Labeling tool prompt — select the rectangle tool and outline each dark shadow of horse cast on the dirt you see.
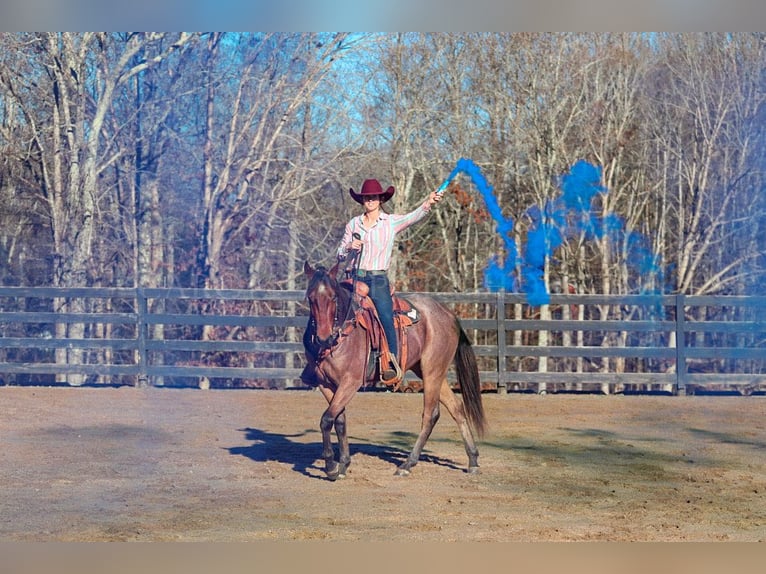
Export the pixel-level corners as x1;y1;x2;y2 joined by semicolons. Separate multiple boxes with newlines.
226;427;461;480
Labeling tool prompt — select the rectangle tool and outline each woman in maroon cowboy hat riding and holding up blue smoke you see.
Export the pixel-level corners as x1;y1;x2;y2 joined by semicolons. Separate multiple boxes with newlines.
338;179;442;381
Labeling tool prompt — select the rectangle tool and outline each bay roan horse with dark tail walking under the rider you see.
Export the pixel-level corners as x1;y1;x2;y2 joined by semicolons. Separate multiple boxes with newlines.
304;262;486;480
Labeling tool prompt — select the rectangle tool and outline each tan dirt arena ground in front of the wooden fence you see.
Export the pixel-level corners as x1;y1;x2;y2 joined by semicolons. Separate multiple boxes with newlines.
0;387;766;542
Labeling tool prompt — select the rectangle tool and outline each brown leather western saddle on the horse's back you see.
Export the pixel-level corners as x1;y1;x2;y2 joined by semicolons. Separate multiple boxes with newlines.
340;279;420;388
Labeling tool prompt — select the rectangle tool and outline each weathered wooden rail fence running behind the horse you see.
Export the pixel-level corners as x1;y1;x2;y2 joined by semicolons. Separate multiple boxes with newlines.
0;287;766;394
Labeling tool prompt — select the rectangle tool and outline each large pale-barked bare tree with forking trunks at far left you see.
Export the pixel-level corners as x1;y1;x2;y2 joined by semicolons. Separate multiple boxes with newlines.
0;33;195;385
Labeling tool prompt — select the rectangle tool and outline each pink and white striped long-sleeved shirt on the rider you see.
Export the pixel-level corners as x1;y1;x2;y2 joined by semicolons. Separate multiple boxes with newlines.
338;200;431;271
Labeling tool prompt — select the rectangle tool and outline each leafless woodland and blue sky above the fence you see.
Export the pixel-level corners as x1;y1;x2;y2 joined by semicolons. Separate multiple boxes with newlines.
0;32;766;300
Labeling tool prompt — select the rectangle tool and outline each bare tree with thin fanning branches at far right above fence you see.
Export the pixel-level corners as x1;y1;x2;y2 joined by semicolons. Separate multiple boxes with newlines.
648;34;766;294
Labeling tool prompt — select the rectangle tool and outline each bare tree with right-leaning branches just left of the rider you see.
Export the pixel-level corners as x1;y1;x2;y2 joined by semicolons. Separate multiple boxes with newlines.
192;34;364;287
